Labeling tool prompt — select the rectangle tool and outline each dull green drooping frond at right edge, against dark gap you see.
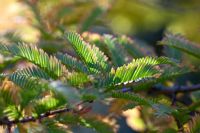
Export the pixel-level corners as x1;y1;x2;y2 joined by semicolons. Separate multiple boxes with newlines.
160;33;200;58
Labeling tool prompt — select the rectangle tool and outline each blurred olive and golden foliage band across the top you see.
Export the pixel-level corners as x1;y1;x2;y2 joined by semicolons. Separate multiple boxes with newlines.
0;0;200;44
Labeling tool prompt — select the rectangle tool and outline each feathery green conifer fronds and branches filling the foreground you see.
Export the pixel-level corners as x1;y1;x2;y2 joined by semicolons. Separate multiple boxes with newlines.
0;32;200;133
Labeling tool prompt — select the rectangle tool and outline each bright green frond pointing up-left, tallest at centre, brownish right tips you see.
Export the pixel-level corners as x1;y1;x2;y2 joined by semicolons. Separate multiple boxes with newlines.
65;32;110;73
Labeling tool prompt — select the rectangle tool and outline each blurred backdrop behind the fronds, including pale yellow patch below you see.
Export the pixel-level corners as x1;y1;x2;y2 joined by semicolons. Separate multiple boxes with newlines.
0;0;200;133
